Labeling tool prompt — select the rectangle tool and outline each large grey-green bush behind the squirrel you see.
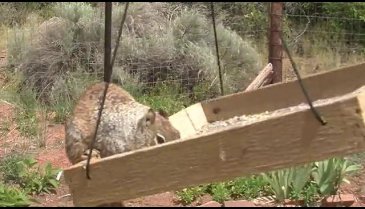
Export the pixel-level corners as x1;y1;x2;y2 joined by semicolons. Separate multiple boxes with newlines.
9;2;261;110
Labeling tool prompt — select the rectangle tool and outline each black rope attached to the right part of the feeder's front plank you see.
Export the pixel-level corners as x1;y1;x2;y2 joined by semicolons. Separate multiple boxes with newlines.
280;35;327;125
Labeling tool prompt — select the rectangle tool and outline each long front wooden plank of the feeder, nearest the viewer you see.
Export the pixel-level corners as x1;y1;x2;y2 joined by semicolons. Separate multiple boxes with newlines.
64;91;365;206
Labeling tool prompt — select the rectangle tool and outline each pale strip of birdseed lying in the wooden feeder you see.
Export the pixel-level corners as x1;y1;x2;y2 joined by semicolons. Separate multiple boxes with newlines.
196;86;365;135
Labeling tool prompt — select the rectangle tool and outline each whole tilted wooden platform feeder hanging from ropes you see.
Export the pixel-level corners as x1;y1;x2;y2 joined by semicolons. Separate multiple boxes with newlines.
64;63;365;206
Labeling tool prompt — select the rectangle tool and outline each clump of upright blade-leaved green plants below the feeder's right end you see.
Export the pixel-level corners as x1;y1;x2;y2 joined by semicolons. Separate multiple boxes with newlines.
262;158;360;204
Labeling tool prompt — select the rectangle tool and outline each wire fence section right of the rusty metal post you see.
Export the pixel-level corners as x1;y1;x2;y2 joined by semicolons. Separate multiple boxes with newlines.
283;2;365;80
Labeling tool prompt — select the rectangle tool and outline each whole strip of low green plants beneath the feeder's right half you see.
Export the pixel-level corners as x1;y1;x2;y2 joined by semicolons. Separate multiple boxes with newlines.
176;158;360;206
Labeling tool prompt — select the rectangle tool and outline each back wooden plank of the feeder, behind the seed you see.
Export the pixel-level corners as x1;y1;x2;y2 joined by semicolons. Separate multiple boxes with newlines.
201;63;365;122
